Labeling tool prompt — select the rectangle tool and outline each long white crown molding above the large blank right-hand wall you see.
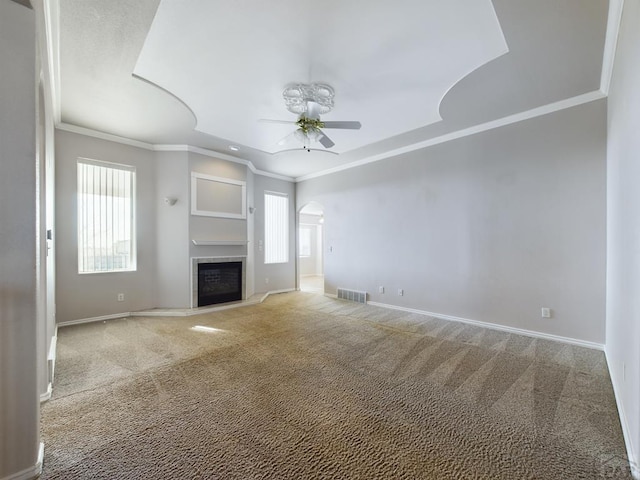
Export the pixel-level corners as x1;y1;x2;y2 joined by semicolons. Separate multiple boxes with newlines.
295;90;606;182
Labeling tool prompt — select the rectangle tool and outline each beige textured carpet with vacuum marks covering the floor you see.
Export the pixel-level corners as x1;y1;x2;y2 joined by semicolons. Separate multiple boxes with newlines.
42;292;630;480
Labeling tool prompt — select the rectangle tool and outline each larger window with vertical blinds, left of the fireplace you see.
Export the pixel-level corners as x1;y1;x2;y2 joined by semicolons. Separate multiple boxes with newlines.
78;159;136;273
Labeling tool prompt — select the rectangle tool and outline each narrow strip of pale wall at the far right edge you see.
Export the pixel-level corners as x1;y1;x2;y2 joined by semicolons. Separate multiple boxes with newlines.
606;0;640;472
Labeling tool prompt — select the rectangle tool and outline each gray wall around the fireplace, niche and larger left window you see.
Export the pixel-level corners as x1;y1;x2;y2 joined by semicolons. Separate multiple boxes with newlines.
56;135;254;312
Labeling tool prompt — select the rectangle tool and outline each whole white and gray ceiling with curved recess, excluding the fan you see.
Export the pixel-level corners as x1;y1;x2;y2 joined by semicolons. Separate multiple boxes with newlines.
60;0;608;177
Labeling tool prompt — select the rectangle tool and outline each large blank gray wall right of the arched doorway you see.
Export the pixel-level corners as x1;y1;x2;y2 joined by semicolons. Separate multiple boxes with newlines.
297;101;606;343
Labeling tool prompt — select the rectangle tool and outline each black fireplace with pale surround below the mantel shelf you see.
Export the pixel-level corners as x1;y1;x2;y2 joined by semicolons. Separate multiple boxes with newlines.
192;257;245;307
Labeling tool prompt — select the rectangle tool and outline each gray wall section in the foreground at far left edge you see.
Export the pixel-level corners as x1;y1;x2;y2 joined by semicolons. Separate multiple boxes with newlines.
0;1;43;478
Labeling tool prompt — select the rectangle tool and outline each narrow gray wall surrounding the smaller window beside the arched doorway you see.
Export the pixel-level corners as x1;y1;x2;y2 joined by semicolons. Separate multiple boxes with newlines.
253;175;296;293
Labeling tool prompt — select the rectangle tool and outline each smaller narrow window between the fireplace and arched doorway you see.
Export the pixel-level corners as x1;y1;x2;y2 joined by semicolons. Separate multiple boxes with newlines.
264;192;289;263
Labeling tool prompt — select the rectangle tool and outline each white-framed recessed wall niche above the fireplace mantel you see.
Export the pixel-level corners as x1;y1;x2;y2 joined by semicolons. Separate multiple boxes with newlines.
191;172;247;220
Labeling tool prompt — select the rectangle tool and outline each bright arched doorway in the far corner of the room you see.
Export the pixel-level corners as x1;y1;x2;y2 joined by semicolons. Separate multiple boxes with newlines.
297;202;324;294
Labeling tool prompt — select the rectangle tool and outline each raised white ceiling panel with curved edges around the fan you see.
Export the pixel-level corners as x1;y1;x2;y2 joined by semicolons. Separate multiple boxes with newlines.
133;0;508;154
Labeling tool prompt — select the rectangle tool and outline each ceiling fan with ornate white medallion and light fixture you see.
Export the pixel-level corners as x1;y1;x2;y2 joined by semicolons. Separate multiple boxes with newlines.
261;83;362;152
